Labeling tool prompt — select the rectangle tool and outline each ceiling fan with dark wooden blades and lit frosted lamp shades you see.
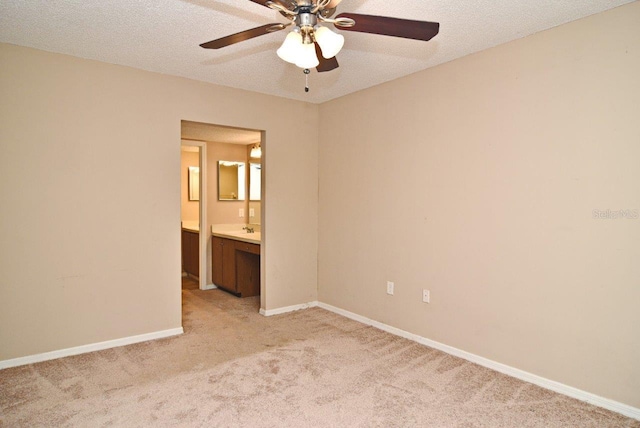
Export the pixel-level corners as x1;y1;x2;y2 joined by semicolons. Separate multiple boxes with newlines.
200;0;440;91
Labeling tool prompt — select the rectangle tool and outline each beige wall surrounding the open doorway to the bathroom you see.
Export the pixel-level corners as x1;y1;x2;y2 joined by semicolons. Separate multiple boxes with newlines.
0;44;318;360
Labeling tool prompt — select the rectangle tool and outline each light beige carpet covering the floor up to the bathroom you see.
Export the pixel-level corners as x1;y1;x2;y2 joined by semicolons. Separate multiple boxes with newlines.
0;280;640;428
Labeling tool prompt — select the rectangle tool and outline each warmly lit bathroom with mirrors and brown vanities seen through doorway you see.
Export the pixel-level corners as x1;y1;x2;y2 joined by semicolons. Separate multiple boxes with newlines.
180;121;264;297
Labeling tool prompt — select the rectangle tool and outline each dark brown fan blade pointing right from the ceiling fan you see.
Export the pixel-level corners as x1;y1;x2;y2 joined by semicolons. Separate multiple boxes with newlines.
336;13;440;41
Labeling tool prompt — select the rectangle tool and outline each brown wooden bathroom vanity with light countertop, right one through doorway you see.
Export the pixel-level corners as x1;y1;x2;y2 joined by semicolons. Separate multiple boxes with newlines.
211;231;260;297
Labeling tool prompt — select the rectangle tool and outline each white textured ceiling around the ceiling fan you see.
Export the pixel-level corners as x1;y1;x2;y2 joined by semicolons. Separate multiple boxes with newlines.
0;0;631;103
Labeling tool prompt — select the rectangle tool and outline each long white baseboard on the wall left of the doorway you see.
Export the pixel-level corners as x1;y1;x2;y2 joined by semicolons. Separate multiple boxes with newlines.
0;327;184;370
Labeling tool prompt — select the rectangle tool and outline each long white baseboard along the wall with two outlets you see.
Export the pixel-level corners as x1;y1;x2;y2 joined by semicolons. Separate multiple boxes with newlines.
317;302;640;420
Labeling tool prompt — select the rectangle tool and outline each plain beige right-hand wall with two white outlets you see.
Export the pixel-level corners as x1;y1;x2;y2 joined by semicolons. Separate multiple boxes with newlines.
318;2;640;407
